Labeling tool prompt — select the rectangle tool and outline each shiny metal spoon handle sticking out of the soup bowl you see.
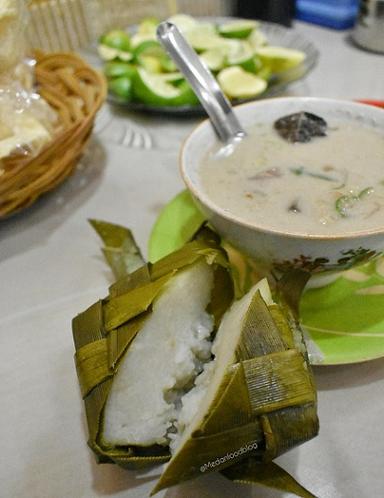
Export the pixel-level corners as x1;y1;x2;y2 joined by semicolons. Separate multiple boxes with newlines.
157;21;245;143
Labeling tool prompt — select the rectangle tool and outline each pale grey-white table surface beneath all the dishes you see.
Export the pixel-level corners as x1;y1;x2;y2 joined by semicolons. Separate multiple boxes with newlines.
0;19;384;498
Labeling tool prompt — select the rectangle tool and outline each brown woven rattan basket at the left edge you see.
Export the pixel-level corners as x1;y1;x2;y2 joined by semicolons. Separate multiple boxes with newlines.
0;53;106;218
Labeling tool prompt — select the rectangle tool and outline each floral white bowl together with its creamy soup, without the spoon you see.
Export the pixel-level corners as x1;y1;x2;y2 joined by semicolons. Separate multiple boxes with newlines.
180;97;384;272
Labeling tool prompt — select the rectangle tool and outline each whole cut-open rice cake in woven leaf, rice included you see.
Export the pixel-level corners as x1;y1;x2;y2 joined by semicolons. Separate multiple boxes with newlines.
73;220;318;497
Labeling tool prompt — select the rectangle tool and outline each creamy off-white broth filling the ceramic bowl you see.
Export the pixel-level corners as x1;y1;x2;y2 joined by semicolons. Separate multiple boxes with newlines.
199;122;384;235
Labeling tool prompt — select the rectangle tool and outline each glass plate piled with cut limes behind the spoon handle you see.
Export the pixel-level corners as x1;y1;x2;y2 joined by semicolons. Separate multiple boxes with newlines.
97;14;318;114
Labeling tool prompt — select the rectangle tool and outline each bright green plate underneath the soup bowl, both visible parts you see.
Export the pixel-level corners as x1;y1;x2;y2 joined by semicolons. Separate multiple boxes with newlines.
148;191;384;365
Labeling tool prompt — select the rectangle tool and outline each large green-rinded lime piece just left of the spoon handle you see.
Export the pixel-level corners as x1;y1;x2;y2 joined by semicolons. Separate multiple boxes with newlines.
133;68;198;106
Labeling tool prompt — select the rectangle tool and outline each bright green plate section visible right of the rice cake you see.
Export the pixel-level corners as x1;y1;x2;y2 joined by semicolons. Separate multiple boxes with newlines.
300;258;384;365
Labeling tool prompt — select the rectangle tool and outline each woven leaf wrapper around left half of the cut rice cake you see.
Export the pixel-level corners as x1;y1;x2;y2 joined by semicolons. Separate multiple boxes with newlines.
72;234;233;469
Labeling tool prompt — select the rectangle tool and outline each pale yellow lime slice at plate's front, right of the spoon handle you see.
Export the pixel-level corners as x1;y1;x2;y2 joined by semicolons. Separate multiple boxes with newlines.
217;66;267;99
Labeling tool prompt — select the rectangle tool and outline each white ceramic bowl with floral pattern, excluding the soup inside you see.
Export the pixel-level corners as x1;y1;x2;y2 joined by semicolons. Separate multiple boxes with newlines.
180;97;384;272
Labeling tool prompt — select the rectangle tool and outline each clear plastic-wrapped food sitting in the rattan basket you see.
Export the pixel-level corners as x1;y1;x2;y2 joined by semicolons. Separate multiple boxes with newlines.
0;0;57;161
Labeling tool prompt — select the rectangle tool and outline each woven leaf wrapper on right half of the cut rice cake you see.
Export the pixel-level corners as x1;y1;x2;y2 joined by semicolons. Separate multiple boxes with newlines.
153;292;319;496
